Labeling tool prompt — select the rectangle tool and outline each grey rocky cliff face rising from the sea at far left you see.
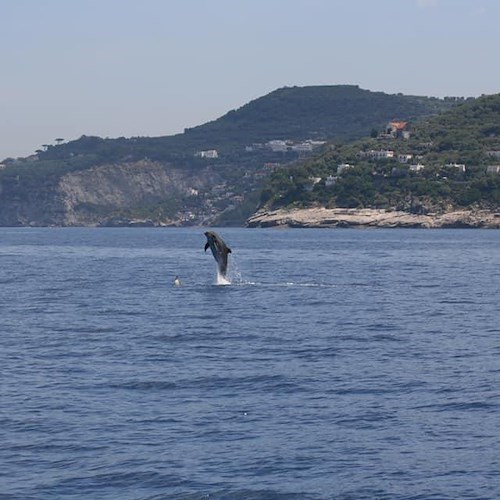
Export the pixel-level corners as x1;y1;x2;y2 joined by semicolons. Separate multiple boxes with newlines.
0;160;219;226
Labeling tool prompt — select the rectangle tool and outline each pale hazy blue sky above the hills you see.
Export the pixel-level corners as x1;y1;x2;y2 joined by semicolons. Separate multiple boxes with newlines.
0;0;500;160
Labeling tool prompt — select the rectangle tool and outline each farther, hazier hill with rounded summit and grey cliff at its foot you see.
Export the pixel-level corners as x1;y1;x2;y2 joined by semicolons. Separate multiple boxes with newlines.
0;85;457;225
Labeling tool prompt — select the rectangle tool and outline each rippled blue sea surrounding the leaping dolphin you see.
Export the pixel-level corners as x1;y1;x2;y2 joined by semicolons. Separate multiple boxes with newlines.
0;228;500;500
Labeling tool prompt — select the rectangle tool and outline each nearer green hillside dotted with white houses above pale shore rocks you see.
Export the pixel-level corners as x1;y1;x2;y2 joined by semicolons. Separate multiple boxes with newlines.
260;94;500;219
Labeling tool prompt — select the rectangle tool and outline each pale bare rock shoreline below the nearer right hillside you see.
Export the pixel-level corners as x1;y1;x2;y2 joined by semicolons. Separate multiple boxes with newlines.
247;207;500;229
